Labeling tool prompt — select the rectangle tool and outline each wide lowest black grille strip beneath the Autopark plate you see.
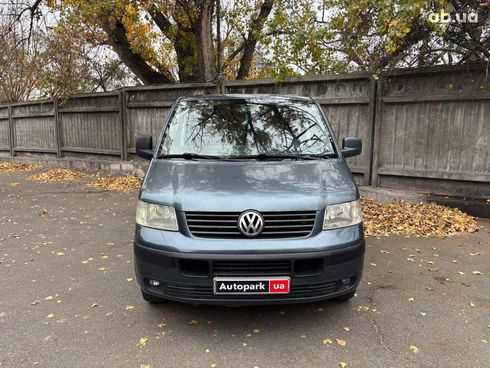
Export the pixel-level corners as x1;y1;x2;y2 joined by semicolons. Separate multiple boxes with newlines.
159;281;339;300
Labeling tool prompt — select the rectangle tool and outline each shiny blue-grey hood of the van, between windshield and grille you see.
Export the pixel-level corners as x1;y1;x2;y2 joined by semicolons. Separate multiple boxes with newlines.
140;159;359;212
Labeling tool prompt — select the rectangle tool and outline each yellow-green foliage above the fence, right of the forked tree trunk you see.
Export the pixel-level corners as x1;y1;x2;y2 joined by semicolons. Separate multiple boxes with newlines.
262;0;490;78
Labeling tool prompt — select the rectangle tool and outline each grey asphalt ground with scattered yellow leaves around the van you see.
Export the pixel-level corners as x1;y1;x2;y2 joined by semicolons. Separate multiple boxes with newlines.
0;170;490;368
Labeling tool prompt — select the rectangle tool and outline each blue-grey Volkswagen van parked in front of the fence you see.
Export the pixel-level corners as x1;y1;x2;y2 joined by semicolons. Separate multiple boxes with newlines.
134;95;365;305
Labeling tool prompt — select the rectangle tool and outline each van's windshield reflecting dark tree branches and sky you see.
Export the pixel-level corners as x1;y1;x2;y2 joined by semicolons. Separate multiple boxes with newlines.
159;99;335;157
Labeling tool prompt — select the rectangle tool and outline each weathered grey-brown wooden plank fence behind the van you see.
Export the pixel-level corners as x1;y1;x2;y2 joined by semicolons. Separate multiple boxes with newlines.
0;64;490;197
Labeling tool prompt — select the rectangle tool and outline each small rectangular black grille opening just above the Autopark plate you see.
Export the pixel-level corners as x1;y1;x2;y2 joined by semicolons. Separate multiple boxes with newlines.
213;261;291;276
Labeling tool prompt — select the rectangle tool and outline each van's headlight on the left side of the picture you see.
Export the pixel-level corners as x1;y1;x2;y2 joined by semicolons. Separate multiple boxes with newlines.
136;201;179;231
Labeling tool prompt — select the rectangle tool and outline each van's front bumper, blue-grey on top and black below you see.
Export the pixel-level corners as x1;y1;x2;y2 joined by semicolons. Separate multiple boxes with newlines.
134;225;365;306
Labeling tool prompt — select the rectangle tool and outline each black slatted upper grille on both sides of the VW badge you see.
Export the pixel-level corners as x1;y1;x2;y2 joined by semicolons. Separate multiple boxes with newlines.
185;211;316;239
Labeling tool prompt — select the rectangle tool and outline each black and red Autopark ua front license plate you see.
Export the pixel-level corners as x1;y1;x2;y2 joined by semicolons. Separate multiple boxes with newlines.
214;277;289;295
